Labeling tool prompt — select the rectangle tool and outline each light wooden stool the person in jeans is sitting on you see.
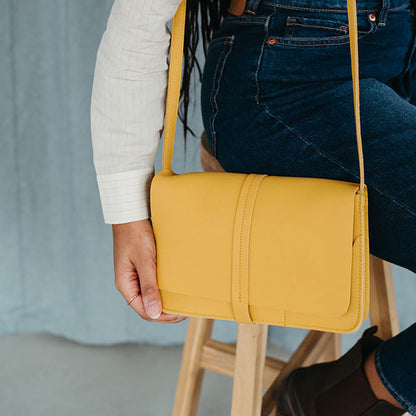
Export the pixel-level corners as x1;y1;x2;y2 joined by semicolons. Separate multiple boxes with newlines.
172;132;399;416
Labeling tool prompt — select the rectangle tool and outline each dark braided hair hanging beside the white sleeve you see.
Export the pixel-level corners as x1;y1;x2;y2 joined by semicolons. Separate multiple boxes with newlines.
179;0;230;158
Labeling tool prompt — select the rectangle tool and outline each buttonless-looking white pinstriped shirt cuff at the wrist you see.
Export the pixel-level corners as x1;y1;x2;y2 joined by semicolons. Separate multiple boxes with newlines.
97;169;154;224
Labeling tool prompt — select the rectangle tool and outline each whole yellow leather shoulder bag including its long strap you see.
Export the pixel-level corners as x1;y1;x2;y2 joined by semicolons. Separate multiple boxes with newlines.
150;0;369;333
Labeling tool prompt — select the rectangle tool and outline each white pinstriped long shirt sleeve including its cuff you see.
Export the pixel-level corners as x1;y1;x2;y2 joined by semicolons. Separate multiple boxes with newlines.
90;0;181;224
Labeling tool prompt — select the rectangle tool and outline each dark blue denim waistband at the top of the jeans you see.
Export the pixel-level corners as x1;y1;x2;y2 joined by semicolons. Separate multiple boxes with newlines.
246;0;411;13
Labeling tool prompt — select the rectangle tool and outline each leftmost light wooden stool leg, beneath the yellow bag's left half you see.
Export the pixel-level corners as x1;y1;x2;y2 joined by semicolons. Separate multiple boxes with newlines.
172;317;214;416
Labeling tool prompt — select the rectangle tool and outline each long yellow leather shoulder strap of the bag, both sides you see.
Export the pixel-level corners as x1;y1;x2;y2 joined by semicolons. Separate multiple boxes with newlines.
162;0;364;194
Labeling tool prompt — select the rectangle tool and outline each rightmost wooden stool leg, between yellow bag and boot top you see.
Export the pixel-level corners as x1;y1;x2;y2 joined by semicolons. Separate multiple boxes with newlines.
370;255;400;339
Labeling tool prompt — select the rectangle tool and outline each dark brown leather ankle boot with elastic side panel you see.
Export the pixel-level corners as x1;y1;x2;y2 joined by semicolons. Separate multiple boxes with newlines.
275;326;405;416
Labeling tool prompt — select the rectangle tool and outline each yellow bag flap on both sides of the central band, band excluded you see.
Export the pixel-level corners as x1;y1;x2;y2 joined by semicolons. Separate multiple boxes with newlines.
150;172;358;316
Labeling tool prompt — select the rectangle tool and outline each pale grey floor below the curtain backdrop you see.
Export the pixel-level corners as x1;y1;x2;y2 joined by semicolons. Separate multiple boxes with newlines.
0;334;286;416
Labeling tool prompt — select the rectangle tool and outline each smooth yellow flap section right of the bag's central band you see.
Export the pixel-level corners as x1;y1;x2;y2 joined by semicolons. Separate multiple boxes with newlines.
248;176;358;316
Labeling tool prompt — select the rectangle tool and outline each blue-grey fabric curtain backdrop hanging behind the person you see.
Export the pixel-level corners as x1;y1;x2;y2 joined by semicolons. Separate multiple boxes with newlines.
0;0;416;350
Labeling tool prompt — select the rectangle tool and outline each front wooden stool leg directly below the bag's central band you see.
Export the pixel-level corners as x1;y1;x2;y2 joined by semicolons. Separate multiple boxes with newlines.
231;324;268;416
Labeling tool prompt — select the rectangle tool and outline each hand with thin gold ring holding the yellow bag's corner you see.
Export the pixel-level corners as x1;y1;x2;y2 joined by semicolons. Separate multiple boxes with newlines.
112;218;186;323
